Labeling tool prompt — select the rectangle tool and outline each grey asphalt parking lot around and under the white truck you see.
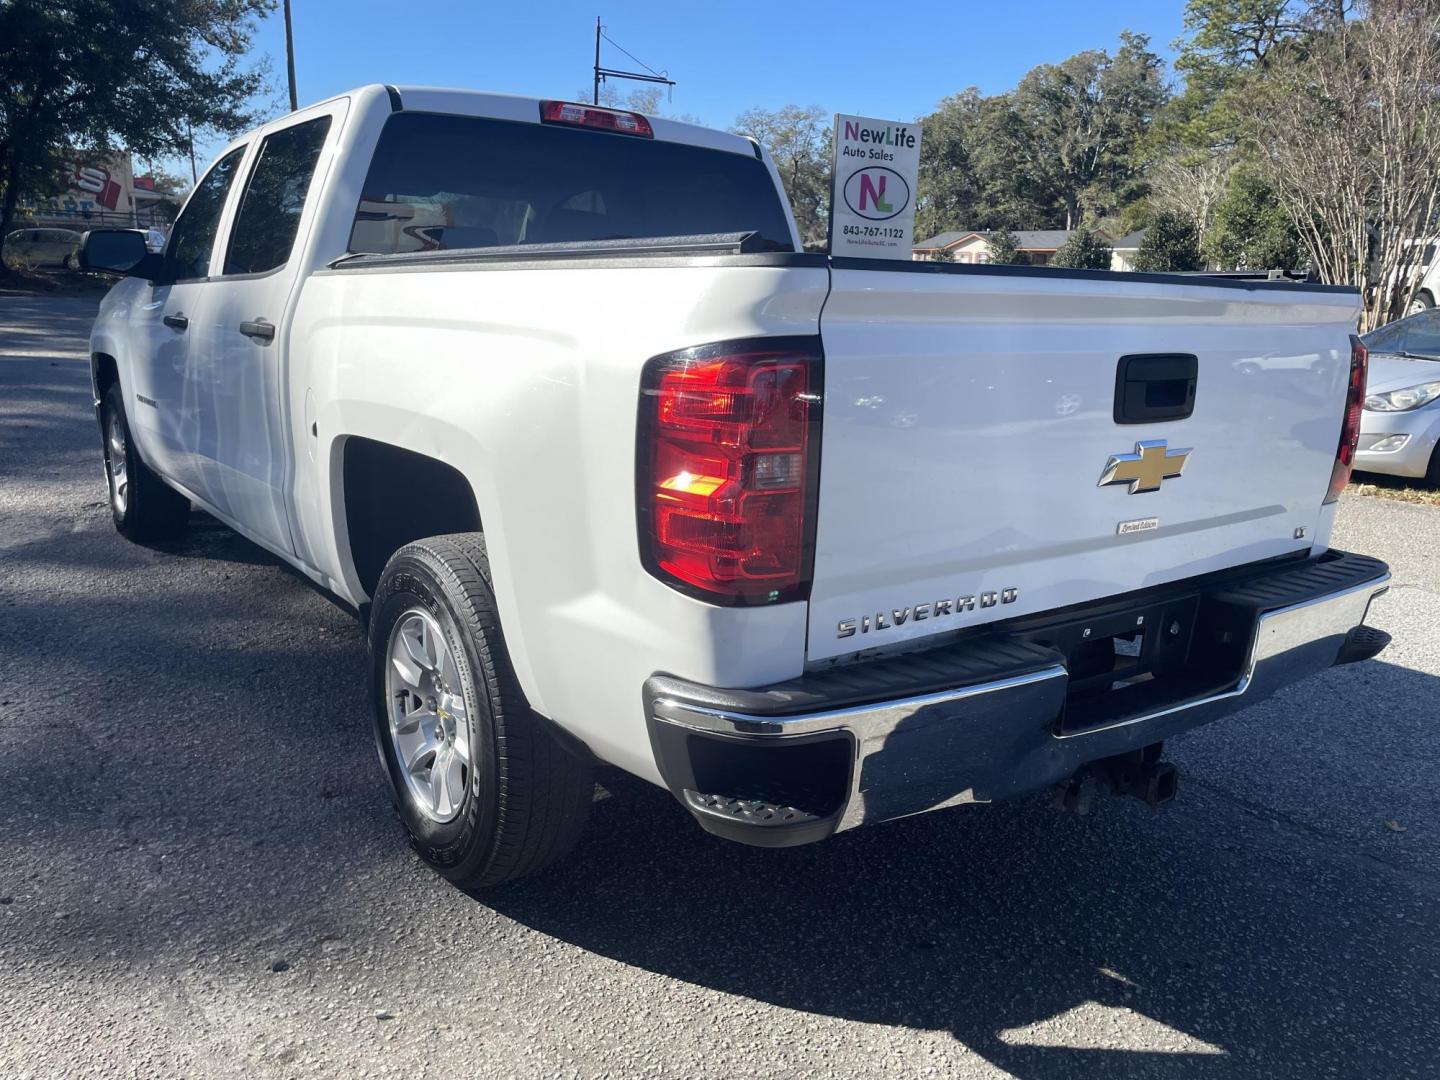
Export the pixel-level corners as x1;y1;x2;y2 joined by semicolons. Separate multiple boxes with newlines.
0;295;1440;1080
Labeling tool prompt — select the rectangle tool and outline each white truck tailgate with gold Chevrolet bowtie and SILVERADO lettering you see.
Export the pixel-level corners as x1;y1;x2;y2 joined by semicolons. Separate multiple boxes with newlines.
808;264;1358;661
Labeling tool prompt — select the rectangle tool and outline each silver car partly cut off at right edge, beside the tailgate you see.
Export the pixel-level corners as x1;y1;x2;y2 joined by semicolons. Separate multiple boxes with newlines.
1355;308;1440;487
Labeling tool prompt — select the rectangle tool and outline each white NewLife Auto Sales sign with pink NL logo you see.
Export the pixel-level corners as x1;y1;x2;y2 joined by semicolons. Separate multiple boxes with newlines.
829;114;920;259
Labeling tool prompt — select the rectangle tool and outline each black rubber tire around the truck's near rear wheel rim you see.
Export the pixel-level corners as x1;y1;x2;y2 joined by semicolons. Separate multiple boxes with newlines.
370;533;595;890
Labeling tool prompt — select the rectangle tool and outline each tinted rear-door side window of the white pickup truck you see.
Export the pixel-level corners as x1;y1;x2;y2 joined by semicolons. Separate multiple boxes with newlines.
225;117;330;274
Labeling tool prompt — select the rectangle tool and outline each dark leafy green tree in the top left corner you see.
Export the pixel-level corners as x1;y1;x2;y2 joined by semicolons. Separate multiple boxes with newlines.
0;0;275;235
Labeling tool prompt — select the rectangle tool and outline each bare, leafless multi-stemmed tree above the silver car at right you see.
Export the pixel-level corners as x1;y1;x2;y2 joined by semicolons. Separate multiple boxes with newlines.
1240;0;1440;330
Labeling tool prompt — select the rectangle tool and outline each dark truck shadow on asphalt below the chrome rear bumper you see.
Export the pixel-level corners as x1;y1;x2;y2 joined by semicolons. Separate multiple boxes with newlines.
485;662;1440;1080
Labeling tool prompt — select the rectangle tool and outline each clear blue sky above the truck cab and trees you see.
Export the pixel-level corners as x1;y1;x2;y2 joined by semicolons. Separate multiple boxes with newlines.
176;0;1184;171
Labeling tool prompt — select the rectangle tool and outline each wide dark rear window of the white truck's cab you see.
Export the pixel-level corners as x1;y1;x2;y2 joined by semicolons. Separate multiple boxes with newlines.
350;112;793;253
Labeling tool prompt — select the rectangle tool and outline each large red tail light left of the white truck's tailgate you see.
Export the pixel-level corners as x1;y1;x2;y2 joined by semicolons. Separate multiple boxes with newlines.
636;338;821;605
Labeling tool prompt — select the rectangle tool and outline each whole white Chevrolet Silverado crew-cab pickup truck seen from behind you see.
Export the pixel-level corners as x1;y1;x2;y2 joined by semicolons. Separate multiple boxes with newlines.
84;86;1388;887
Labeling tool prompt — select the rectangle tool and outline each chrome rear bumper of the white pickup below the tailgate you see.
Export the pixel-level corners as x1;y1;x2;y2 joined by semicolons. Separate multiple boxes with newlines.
645;554;1390;845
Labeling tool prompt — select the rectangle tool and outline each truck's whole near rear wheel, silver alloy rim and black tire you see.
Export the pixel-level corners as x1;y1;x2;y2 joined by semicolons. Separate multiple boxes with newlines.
370;534;595;888
